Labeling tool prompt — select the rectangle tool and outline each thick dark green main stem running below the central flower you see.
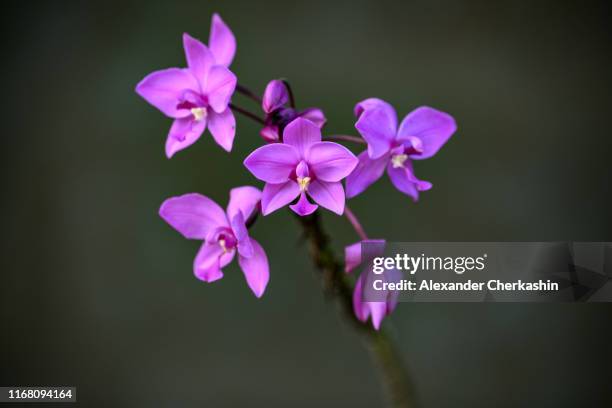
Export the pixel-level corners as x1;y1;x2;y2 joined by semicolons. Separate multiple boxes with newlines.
297;212;416;408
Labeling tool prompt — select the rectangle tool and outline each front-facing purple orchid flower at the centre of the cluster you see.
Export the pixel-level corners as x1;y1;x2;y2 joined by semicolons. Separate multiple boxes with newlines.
244;118;357;216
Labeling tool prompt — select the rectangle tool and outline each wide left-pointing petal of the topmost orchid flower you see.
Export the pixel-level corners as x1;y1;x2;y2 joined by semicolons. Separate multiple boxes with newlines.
136;68;200;118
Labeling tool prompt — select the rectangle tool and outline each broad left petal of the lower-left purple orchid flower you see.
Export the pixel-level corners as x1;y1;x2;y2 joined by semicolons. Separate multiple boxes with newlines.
159;193;228;239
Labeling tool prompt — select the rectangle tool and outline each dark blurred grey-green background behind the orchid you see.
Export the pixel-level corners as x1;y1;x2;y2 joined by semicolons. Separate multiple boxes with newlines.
0;0;612;407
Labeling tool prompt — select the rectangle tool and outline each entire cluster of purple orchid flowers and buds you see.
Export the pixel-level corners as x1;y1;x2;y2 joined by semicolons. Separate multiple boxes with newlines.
136;14;456;330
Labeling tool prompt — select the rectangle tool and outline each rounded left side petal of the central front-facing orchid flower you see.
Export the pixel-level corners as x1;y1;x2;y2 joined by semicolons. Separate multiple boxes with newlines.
244;143;300;184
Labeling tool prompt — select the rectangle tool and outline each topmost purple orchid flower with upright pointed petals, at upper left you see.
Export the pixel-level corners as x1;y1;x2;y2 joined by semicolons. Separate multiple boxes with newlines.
136;14;236;158
